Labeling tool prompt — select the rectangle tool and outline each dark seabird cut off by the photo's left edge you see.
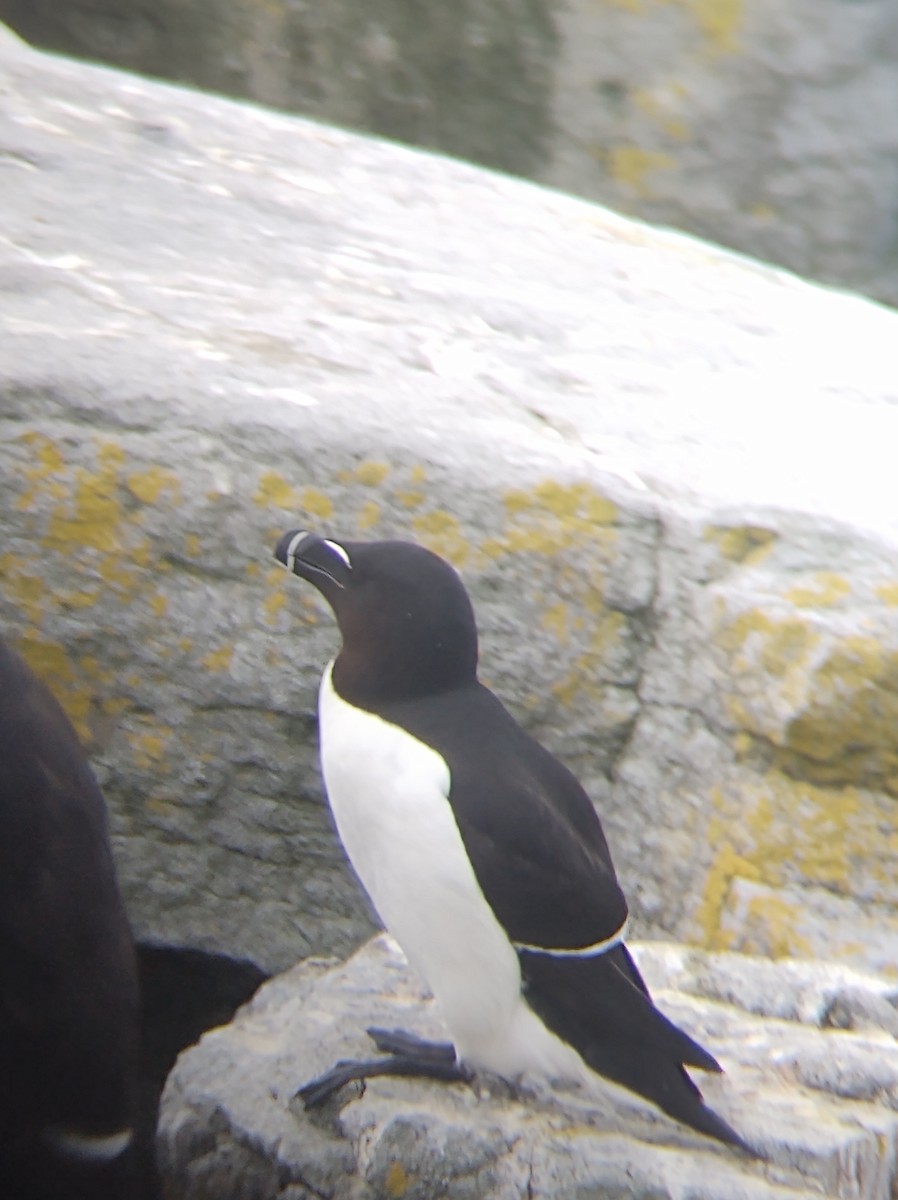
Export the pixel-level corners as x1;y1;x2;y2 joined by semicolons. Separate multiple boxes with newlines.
0;641;139;1200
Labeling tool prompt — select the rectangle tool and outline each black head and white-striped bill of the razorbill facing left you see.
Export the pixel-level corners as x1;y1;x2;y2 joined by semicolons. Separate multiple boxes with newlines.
275;529;477;708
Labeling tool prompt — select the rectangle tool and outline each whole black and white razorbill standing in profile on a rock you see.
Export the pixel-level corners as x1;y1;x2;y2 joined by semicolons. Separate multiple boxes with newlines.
275;530;747;1148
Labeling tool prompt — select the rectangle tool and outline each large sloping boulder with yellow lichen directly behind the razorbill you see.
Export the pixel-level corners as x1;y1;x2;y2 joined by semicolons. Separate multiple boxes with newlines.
0;36;898;971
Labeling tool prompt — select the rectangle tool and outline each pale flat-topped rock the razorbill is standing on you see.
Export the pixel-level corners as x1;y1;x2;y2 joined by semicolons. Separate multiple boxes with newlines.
160;936;898;1200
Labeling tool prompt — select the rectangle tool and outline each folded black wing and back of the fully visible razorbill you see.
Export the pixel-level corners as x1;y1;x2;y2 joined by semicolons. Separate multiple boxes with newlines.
383;684;627;949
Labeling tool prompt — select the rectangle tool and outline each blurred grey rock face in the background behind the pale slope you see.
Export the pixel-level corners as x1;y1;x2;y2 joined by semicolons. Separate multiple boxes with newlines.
0;0;898;304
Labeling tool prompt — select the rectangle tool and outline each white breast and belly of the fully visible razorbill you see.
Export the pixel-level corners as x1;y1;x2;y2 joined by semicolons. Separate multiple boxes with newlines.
319;664;582;1075
